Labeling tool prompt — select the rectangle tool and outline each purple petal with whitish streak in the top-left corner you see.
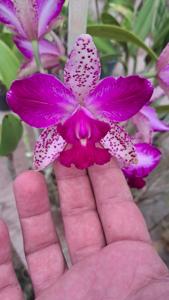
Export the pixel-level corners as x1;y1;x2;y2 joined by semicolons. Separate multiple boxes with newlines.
0;0;25;36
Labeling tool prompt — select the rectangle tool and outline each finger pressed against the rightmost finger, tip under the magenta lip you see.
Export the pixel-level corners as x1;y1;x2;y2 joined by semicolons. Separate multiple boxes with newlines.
54;163;105;263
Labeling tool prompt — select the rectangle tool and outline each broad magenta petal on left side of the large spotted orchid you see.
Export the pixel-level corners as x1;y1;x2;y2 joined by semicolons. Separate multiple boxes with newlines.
7;73;78;128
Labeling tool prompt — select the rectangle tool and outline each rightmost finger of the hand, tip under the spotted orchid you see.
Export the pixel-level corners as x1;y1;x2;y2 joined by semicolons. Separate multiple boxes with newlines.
89;160;150;243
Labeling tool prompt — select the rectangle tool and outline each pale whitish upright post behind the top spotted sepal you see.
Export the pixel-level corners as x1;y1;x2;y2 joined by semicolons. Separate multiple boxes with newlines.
68;0;89;53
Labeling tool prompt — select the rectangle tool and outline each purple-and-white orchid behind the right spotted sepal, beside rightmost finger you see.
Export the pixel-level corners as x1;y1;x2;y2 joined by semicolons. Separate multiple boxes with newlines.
123;143;161;189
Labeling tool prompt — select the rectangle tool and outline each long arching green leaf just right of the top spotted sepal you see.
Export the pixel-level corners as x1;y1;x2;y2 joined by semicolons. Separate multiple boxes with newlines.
87;25;157;60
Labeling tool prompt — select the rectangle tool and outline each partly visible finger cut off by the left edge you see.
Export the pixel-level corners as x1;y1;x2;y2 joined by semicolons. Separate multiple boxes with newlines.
0;220;23;300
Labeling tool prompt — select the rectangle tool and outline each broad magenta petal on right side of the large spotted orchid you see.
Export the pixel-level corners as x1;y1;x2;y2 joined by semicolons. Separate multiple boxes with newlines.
85;75;153;122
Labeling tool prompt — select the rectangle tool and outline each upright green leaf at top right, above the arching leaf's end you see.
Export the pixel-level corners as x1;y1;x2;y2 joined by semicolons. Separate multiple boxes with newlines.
133;0;159;40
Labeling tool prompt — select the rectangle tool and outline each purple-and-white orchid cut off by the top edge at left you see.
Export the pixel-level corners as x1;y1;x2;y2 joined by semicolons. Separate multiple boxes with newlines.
0;0;64;41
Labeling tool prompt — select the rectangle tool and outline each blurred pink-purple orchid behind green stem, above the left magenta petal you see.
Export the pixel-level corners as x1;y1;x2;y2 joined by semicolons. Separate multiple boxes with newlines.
14;38;65;78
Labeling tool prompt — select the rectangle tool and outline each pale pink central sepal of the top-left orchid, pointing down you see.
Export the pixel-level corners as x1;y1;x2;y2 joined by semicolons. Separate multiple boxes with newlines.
13;0;38;40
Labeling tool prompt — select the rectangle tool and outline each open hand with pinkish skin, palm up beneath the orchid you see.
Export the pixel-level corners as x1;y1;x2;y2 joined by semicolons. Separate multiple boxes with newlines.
0;161;169;300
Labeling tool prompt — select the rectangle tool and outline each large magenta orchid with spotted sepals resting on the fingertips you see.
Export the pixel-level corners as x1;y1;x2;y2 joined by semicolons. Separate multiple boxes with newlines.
7;34;153;170
